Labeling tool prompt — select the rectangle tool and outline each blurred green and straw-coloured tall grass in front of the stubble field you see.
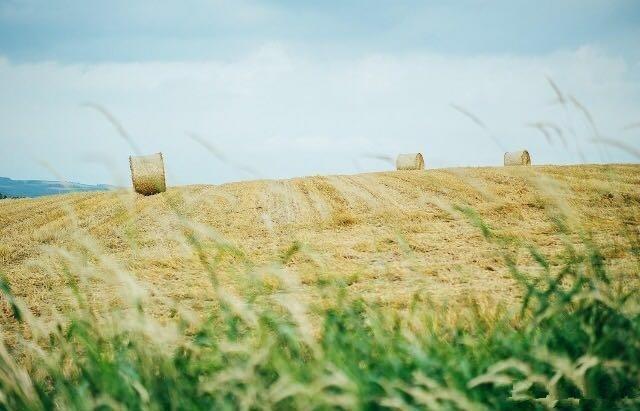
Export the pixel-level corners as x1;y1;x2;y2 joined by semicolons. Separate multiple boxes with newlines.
0;187;640;410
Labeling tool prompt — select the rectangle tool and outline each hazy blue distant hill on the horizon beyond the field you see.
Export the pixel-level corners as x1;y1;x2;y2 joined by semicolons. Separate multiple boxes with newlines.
0;177;113;197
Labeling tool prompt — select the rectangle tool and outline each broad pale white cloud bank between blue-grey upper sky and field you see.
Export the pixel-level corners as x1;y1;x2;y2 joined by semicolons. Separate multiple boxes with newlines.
0;44;640;184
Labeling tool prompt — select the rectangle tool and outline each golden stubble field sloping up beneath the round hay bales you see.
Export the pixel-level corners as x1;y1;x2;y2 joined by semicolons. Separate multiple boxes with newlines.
0;165;640;326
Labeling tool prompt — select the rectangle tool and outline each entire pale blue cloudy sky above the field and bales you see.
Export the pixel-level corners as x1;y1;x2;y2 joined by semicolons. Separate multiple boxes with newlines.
0;0;640;184
